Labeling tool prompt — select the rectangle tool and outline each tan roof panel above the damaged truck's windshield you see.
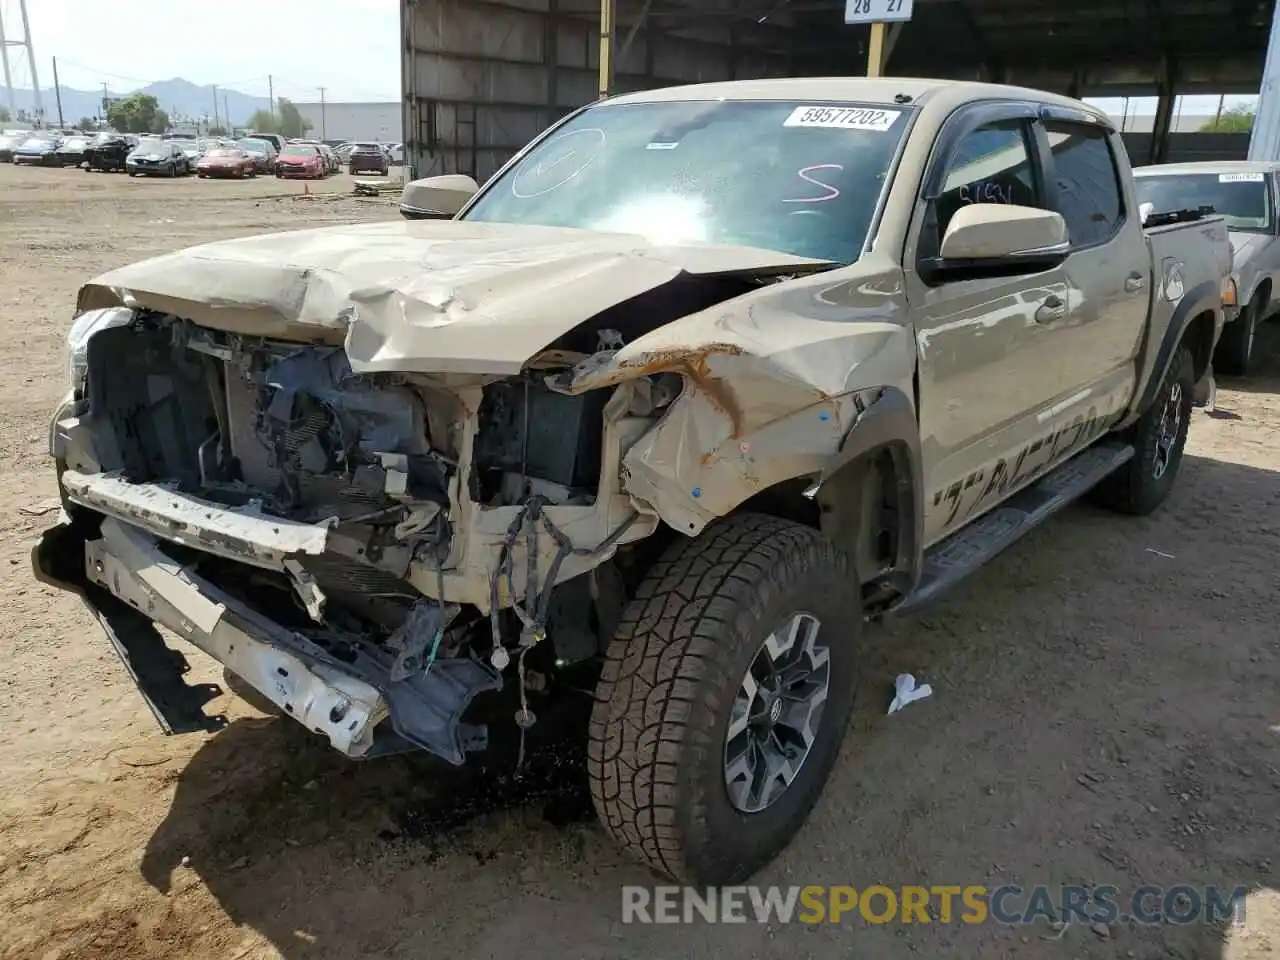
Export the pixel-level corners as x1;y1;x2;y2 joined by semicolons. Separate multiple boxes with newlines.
605;77;1111;127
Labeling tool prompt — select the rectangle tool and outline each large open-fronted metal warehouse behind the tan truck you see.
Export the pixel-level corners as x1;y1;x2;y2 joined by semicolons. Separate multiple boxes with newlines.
401;0;1275;179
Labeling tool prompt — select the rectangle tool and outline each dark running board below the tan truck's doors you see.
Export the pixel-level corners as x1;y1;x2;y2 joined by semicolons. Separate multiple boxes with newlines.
893;443;1134;613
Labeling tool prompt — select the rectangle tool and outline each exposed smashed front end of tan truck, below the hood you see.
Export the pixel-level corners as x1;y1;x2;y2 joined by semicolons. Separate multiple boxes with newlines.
54;264;803;763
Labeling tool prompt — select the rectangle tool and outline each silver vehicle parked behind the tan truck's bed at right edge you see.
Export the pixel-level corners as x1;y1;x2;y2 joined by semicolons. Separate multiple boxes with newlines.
1133;160;1280;376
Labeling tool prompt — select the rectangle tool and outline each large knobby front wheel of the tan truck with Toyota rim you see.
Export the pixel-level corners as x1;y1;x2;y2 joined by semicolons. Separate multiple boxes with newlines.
588;513;861;884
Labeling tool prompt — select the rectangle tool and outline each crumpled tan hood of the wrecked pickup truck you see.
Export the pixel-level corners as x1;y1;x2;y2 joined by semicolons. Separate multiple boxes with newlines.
77;220;826;374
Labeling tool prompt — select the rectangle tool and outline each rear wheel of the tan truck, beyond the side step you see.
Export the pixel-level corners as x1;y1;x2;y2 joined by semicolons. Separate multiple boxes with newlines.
1094;346;1196;517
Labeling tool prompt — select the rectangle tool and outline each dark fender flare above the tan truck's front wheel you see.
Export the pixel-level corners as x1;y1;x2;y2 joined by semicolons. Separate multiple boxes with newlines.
814;387;924;596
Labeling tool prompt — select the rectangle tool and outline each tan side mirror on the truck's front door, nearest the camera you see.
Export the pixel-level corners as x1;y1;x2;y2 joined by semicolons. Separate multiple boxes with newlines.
929;204;1071;279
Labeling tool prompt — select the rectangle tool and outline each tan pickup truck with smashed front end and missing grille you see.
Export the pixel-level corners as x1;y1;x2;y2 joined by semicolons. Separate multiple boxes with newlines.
35;79;1231;882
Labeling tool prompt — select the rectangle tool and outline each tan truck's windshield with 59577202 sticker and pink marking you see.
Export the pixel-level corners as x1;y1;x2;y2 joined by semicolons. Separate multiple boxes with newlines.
465;100;908;264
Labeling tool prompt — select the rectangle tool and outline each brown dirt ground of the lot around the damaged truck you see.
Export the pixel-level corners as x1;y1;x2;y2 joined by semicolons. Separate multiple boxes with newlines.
0;165;1280;960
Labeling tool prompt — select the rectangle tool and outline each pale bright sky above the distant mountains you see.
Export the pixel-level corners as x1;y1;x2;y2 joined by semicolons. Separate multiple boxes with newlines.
0;0;401;101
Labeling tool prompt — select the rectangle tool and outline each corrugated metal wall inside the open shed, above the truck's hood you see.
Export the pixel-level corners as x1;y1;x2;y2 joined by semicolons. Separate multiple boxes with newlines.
402;0;790;182
